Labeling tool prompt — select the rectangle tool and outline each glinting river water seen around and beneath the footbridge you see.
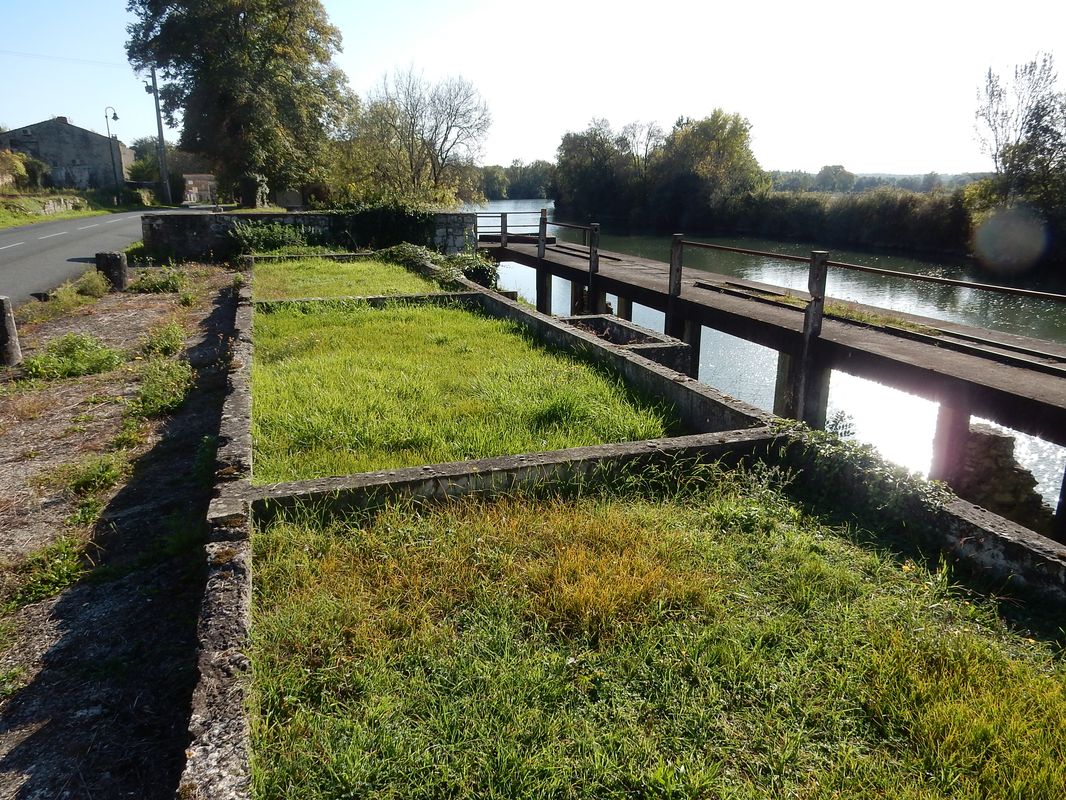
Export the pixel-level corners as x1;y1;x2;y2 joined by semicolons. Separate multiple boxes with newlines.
470;201;1066;508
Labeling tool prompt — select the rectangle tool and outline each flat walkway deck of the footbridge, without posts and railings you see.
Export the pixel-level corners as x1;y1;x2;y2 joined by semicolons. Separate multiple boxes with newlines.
480;237;1066;452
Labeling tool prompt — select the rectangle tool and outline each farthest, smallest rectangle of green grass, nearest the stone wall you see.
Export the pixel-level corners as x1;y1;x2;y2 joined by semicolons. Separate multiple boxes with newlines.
253;258;440;300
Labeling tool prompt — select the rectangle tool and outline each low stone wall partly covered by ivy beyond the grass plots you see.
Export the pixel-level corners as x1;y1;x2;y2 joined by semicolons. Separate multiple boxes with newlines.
141;211;477;260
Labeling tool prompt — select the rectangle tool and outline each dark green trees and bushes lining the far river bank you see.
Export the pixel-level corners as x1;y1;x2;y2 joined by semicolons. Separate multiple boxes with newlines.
482;109;1066;273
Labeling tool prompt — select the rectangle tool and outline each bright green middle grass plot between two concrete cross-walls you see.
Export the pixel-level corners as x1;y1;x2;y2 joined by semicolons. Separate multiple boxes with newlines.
252;304;674;482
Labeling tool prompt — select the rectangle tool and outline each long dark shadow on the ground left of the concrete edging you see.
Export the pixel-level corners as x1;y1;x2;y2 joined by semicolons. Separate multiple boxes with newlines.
0;291;235;800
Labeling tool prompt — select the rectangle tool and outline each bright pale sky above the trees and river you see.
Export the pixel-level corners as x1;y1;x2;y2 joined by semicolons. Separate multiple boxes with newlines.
0;0;1066;175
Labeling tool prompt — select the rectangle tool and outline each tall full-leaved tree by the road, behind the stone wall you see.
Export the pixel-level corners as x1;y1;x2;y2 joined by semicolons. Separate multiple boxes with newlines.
126;0;349;199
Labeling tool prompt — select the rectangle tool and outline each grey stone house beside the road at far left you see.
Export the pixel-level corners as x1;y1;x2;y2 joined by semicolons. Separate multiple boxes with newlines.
0;116;134;189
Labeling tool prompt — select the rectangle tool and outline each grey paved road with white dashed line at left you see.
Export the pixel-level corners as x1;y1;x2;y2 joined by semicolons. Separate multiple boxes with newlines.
0;211;150;305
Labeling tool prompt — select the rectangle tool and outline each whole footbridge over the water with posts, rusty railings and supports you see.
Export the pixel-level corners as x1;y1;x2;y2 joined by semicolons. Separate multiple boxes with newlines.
479;211;1066;541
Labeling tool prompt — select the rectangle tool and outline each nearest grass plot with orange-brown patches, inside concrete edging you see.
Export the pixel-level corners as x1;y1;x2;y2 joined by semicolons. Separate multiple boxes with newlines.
252;470;1066;800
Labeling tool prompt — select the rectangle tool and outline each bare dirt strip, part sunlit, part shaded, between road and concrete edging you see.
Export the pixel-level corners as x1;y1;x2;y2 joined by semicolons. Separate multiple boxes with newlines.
0;268;233;799
